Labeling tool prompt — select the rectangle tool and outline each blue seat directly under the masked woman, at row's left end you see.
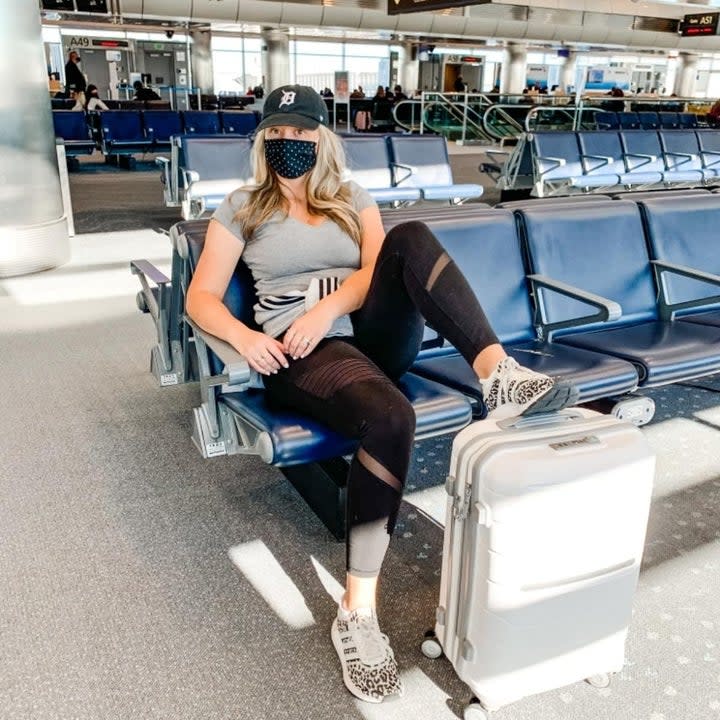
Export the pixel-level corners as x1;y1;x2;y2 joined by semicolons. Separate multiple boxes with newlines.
172;225;472;536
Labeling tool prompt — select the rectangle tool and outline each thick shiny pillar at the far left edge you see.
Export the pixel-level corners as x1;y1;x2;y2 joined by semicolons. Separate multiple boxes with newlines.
0;2;70;277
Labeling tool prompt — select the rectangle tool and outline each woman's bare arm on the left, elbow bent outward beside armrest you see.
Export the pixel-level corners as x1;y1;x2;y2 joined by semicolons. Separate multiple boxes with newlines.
185;220;287;375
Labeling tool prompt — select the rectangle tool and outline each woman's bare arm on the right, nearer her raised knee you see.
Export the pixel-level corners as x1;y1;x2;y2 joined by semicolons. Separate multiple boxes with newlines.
285;205;385;358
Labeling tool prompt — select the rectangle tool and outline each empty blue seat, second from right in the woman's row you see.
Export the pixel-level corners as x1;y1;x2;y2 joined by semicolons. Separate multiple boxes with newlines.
517;200;720;387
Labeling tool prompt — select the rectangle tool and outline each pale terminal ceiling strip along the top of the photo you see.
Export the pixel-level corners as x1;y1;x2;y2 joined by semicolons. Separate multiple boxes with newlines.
50;0;720;53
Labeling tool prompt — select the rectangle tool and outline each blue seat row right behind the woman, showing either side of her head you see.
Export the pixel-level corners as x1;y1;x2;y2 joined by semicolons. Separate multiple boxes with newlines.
157;133;483;219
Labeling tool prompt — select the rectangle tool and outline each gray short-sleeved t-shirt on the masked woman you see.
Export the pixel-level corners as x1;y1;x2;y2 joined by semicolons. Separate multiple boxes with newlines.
213;180;375;337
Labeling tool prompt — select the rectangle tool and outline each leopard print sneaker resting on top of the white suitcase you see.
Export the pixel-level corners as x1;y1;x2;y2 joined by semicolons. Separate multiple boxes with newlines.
480;357;578;420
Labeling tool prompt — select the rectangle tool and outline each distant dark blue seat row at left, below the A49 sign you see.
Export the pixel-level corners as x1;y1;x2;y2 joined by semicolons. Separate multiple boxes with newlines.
53;110;258;168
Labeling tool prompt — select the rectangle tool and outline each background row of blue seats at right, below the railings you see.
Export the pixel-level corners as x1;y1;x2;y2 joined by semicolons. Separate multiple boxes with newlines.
496;128;720;197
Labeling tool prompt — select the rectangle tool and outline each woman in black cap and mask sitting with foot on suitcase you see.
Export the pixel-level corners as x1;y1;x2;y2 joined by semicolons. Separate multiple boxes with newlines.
187;85;573;702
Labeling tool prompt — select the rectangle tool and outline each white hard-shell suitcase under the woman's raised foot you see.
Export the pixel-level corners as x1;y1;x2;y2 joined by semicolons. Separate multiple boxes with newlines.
423;408;655;718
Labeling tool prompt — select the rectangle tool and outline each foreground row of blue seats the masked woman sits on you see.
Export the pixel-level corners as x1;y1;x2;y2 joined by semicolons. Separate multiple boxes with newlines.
131;193;720;536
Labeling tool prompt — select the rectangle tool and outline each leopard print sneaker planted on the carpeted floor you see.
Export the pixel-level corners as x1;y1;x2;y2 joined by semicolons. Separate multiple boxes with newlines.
330;607;403;703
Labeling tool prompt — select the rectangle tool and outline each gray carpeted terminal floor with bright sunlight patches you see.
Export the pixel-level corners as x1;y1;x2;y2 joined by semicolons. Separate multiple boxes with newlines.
0;143;720;720
